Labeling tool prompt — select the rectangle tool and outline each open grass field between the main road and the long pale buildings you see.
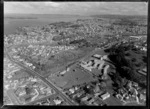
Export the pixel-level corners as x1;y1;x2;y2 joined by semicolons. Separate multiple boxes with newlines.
49;65;94;88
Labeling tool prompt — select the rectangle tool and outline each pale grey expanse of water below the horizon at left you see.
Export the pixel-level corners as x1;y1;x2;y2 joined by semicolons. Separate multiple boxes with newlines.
4;16;91;34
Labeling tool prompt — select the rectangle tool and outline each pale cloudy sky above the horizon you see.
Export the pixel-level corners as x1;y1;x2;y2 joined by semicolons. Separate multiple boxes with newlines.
4;2;148;15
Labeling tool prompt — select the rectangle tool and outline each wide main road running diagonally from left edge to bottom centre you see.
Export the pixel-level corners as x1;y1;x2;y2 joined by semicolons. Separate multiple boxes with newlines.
5;48;77;105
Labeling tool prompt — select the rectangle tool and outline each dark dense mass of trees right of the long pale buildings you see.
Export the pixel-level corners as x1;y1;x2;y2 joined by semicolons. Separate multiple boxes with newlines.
105;45;144;88
